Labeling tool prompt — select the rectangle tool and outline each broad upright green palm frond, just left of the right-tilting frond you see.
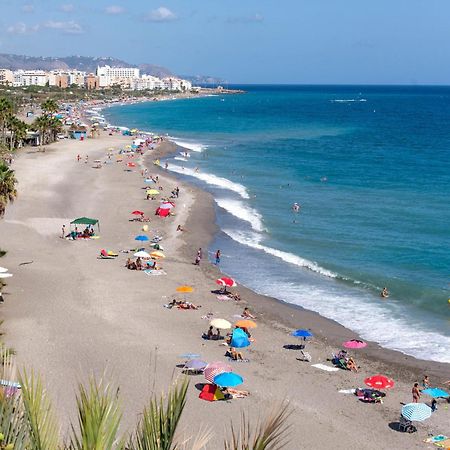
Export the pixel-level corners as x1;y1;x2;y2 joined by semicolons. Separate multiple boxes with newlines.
69;378;122;450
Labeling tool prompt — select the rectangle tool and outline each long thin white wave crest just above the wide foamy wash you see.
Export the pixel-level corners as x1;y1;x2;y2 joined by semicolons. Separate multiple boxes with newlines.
223;229;338;278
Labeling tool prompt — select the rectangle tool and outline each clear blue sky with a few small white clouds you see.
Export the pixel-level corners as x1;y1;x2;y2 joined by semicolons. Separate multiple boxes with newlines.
0;0;450;84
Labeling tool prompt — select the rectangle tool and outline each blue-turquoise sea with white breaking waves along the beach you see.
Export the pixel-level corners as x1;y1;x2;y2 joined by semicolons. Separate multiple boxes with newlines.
105;86;450;362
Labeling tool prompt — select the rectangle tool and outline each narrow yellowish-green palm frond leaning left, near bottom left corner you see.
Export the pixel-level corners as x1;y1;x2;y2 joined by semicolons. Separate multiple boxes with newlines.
20;370;59;450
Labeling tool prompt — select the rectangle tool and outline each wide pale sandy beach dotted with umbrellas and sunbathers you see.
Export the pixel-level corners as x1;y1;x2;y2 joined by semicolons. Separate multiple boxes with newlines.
0;134;450;450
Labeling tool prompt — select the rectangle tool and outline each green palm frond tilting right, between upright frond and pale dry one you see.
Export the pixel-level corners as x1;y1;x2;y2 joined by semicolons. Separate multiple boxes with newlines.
127;378;189;450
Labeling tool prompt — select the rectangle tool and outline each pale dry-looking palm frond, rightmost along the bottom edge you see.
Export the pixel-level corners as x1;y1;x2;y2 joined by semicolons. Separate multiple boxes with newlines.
224;403;291;450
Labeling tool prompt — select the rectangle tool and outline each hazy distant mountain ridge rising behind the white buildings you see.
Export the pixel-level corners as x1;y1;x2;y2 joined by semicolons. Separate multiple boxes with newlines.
0;53;222;84
